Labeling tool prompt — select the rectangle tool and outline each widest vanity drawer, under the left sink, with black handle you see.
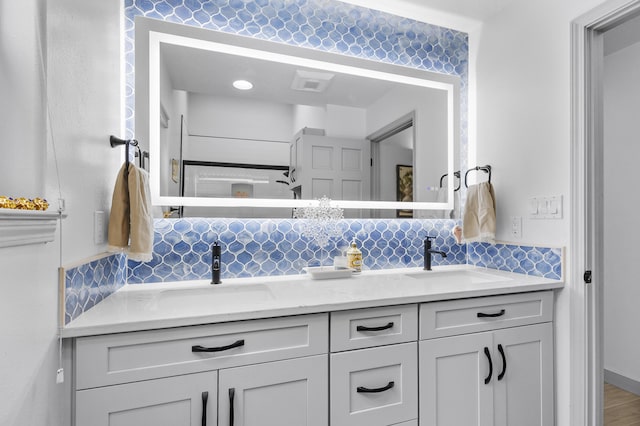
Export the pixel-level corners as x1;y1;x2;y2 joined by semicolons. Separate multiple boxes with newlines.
75;314;328;389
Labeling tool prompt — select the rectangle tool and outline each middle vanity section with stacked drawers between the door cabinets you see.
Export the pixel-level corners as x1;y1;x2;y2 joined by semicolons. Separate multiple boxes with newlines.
329;304;418;426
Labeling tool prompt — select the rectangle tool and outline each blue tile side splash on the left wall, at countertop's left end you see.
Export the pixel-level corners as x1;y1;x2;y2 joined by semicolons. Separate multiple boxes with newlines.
64;254;126;324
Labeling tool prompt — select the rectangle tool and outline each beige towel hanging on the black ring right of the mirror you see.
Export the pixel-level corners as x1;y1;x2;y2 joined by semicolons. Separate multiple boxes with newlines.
462;182;496;243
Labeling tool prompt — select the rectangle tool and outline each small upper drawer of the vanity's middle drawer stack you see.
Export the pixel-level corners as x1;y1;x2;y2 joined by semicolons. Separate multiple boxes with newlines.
331;305;418;352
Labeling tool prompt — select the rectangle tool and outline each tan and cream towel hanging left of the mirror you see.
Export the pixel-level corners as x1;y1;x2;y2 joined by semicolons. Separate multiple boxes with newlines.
107;163;153;262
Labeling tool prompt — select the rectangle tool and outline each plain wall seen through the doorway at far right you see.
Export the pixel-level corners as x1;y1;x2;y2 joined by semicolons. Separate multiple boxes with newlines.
603;43;640;382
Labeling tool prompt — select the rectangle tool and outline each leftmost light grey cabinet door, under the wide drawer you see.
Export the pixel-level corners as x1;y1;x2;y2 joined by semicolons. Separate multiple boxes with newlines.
75;371;218;426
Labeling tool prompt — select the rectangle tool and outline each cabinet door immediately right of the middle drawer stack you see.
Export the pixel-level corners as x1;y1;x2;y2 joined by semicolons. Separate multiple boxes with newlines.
419;332;496;426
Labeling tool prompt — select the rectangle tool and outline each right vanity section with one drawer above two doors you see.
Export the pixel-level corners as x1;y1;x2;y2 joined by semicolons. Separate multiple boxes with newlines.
419;291;554;426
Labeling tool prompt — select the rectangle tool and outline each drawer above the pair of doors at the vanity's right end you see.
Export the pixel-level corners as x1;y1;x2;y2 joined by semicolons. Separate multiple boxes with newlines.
420;291;553;339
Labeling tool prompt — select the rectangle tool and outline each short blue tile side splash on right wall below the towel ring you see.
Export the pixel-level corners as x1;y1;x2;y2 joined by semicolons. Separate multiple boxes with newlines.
467;243;563;280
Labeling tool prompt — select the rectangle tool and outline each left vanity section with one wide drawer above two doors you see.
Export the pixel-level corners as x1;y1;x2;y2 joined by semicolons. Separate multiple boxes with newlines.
75;314;328;426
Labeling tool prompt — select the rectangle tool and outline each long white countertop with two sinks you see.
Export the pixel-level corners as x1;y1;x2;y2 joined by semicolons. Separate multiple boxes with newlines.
61;265;564;338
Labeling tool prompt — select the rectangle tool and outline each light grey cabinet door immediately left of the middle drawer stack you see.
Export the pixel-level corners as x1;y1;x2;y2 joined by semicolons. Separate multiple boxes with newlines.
219;355;329;426
